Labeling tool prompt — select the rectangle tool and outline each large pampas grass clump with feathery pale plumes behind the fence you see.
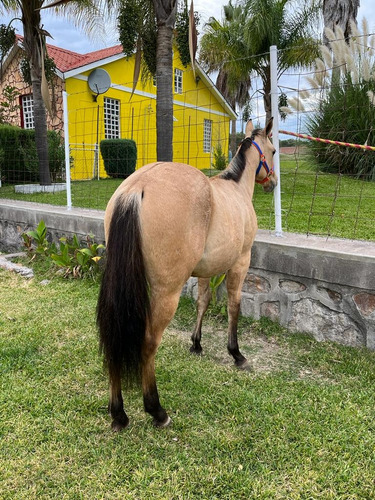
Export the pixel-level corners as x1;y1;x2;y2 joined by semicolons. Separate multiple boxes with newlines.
302;21;375;181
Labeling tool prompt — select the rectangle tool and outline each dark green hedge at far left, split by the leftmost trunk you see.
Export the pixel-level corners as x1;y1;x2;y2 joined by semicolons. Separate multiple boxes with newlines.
0;125;65;184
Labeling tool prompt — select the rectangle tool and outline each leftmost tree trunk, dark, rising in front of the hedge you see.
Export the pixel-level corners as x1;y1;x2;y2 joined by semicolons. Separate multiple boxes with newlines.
22;5;51;185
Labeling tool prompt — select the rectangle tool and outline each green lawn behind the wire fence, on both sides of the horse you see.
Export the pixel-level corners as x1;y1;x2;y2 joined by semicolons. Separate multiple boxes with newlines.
0;155;375;240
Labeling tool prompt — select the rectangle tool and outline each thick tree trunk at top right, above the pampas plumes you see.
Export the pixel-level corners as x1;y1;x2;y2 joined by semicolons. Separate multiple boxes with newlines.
323;0;359;46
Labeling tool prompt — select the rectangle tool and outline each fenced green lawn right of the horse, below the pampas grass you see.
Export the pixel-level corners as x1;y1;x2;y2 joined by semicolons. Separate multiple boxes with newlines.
254;156;375;240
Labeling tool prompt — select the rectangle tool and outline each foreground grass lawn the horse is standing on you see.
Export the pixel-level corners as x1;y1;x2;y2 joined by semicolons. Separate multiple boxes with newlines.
0;264;375;500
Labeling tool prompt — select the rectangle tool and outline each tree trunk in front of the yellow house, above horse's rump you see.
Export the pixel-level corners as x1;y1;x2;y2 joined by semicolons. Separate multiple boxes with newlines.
156;25;173;161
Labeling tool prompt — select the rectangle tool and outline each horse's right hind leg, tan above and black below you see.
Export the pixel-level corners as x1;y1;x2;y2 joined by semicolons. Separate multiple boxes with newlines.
142;292;180;427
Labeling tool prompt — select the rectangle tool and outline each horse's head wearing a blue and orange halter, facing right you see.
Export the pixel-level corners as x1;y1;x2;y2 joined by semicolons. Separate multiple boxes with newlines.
245;118;277;193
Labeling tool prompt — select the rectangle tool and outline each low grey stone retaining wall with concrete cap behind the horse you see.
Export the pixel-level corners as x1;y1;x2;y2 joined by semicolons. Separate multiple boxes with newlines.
0;200;375;349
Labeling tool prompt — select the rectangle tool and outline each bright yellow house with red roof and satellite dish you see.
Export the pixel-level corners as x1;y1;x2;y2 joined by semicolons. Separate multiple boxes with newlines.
0;37;236;180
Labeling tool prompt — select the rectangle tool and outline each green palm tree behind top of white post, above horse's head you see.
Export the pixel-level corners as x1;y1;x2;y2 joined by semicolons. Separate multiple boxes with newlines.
201;0;319;124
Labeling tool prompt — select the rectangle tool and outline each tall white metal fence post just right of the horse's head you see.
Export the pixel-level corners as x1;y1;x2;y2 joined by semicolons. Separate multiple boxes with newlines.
270;45;283;236
